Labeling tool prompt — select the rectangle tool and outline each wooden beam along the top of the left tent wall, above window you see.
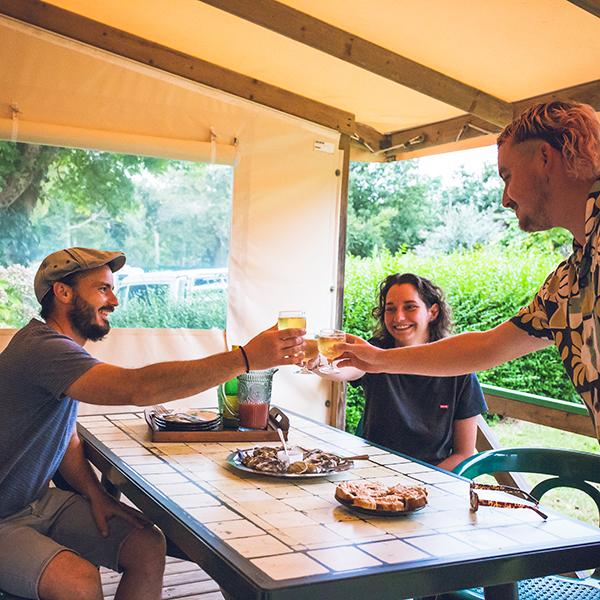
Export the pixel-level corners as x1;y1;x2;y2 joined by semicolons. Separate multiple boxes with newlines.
0;0;355;135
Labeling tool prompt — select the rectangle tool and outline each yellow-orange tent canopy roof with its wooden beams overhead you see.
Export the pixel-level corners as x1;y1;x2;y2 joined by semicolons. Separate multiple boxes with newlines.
0;0;600;160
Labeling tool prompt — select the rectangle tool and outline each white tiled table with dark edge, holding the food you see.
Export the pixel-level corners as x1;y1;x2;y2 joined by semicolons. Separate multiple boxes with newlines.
79;411;600;600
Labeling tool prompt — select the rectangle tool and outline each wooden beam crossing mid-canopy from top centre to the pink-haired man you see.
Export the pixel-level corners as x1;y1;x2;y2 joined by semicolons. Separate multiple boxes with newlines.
201;0;512;126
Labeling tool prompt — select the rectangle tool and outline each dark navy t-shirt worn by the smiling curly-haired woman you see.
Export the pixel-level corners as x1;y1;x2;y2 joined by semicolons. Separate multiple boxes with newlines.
350;339;487;465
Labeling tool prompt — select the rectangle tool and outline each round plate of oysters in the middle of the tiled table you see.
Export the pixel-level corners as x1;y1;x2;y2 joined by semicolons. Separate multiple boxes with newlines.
227;446;354;478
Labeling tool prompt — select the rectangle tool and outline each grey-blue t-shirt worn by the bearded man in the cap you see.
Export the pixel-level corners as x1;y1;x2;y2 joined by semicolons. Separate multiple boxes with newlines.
0;319;99;518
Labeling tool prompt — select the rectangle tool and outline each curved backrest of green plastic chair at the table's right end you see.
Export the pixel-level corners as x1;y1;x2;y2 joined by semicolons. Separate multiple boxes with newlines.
454;448;600;515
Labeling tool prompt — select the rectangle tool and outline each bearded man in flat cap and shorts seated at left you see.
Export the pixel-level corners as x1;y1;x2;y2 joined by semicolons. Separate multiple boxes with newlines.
0;248;304;600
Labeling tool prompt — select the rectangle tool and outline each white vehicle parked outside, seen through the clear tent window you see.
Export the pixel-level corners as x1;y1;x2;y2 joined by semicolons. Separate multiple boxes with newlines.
116;269;227;307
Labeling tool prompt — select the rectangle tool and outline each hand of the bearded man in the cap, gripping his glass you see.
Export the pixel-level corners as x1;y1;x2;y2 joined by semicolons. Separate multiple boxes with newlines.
244;325;306;371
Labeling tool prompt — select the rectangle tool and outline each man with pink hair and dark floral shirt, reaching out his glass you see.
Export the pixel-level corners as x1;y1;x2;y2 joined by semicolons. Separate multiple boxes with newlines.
339;101;600;440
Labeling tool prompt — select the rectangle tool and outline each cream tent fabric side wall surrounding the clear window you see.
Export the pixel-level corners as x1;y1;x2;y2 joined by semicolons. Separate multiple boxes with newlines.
0;18;342;421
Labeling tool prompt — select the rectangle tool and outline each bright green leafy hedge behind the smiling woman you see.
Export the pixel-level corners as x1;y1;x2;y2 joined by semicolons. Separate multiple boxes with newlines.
344;247;581;431
